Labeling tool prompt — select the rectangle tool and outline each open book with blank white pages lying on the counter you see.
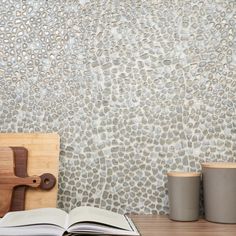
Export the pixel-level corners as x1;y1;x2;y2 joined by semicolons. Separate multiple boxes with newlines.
0;207;140;236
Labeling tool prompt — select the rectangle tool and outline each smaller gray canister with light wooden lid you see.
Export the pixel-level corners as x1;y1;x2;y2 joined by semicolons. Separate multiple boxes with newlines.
167;172;201;221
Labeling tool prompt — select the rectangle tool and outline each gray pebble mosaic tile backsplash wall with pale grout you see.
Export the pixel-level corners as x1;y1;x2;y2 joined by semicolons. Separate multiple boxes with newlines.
0;0;236;214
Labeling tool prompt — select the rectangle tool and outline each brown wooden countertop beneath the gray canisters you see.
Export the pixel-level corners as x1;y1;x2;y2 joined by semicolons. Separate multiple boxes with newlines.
131;215;236;236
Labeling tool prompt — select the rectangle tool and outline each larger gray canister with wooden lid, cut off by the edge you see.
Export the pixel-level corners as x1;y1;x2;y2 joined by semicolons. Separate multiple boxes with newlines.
202;162;236;223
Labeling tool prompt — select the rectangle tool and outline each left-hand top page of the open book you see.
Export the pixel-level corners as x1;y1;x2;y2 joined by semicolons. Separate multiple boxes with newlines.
0;208;68;228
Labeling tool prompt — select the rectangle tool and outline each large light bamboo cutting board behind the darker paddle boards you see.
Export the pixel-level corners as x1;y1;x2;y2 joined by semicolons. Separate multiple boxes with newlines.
0;133;60;209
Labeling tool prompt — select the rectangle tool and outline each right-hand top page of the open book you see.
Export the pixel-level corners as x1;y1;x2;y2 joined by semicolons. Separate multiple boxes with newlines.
68;207;132;231
